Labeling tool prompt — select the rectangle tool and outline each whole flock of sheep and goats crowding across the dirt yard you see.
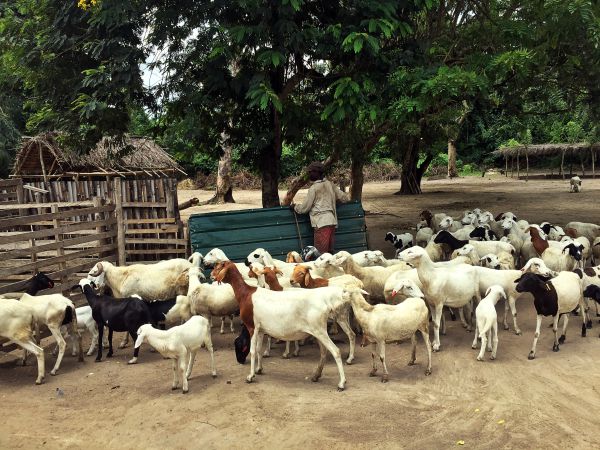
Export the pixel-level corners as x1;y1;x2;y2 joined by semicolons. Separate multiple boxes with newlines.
0;209;600;393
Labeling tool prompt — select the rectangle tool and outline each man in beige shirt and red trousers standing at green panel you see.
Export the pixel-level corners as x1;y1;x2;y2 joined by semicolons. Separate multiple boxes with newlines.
290;162;349;253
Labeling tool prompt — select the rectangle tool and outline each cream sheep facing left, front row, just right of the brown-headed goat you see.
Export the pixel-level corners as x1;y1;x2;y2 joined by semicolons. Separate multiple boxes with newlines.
344;280;431;383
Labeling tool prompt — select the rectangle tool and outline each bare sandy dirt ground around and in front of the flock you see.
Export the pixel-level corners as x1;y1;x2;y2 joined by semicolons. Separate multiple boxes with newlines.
0;176;600;449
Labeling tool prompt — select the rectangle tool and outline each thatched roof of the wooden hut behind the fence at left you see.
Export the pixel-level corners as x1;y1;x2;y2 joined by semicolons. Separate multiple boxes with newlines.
12;133;183;177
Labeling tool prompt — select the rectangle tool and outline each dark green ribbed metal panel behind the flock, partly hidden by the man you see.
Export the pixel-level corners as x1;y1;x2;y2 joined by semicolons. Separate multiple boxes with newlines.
189;202;368;262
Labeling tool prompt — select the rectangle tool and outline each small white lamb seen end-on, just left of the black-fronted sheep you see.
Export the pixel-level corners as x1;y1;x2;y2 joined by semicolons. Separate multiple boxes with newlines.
471;284;506;361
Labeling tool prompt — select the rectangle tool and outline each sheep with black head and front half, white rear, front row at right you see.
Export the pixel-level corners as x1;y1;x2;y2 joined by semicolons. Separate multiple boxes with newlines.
515;272;586;359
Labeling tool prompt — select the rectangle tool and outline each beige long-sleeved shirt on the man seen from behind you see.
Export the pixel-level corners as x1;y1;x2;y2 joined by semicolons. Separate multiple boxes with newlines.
294;178;349;228
